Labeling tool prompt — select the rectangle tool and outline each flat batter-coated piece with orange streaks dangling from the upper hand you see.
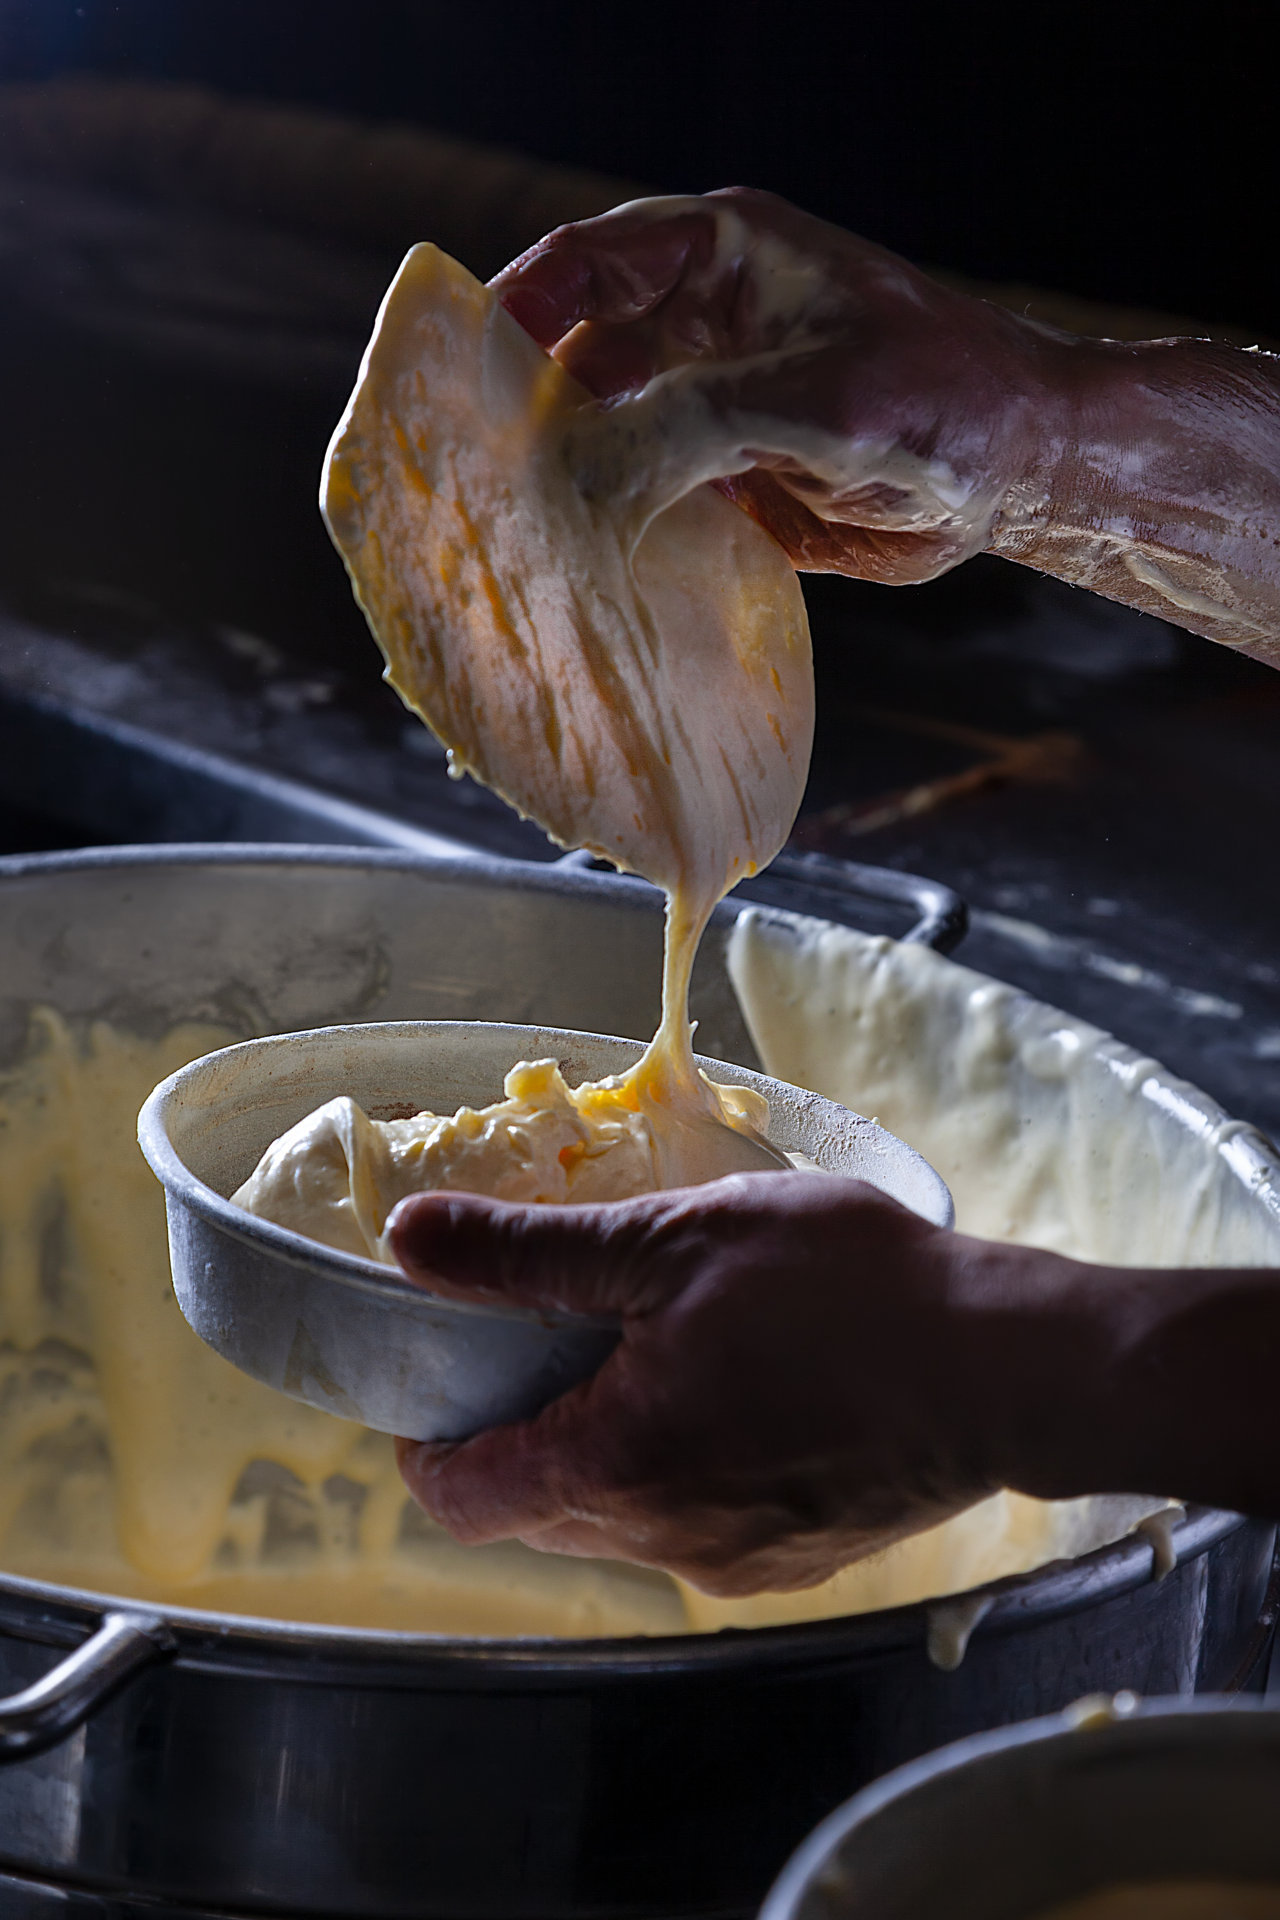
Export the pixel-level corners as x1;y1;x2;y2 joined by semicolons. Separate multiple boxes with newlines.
320;246;814;933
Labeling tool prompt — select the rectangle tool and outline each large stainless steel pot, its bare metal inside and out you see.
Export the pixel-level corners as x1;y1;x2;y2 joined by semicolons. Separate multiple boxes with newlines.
0;847;1274;1920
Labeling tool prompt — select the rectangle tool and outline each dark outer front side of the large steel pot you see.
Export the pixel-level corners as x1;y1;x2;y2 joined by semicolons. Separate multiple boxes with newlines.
0;1513;1274;1920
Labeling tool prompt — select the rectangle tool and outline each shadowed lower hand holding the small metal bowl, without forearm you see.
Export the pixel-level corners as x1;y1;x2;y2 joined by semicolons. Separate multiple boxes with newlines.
391;1173;1073;1596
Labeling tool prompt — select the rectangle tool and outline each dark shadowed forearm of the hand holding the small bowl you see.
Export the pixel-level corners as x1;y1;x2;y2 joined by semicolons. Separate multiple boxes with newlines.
977;1250;1280;1519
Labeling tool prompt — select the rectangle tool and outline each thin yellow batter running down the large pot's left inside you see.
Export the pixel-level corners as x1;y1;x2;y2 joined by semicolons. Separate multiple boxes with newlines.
0;1010;687;1634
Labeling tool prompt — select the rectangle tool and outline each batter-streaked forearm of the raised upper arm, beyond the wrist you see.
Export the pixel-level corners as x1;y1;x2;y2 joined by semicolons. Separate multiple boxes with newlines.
990;340;1280;664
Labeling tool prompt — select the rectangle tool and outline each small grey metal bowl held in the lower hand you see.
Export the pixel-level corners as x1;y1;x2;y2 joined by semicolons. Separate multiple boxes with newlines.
138;1020;954;1440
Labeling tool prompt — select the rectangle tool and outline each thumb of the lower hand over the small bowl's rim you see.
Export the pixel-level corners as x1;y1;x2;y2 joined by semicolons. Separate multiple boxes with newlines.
388;1192;687;1317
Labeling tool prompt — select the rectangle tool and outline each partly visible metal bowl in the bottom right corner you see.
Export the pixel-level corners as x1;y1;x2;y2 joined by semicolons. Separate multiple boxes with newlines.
760;1695;1280;1920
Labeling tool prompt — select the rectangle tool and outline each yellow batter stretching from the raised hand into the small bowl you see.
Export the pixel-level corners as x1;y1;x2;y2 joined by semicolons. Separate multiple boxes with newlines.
234;246;814;1260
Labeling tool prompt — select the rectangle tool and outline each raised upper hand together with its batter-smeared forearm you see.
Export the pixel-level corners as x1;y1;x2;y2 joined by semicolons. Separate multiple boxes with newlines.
493;188;1280;666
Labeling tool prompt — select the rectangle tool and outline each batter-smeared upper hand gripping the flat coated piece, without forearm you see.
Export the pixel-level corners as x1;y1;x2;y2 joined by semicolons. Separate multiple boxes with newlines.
493;188;1069;586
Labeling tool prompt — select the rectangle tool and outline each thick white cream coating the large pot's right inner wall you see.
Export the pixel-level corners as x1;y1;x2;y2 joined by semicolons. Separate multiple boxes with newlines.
727;910;1280;1267
